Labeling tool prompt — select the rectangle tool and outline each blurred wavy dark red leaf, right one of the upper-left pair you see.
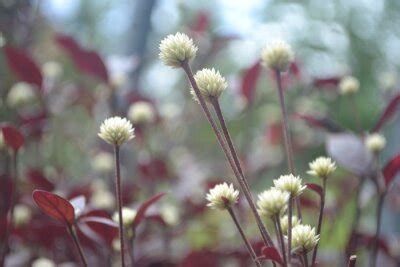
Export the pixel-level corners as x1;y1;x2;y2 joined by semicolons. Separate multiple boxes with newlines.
56;34;108;83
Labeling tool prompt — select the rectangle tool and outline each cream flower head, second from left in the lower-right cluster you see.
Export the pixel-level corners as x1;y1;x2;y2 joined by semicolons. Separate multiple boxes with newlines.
257;187;289;217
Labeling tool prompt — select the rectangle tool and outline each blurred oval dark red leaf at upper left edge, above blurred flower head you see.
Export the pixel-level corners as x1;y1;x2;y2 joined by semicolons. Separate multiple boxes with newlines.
4;45;43;88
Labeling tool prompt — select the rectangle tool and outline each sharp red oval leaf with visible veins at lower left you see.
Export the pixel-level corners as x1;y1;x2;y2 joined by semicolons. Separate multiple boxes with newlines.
32;190;75;225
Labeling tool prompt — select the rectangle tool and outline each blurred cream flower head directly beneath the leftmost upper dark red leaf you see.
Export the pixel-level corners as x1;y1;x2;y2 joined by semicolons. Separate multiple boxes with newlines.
6;82;36;107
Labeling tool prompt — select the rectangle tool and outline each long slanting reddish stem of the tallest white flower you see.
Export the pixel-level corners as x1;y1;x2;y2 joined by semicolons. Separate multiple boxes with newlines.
182;61;274;249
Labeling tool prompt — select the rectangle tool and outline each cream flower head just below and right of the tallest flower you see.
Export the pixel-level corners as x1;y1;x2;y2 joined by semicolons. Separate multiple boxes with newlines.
191;68;228;101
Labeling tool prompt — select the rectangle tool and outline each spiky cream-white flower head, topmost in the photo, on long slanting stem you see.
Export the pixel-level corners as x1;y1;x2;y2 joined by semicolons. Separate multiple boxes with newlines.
159;32;197;68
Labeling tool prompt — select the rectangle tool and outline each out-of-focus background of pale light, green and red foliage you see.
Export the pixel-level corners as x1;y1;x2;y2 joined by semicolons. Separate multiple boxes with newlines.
0;0;400;266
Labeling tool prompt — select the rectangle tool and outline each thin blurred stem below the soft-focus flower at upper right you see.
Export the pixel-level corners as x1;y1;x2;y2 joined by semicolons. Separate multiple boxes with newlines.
275;70;302;221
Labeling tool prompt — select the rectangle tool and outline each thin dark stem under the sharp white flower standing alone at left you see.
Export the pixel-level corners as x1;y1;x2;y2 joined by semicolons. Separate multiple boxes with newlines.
114;145;125;267
